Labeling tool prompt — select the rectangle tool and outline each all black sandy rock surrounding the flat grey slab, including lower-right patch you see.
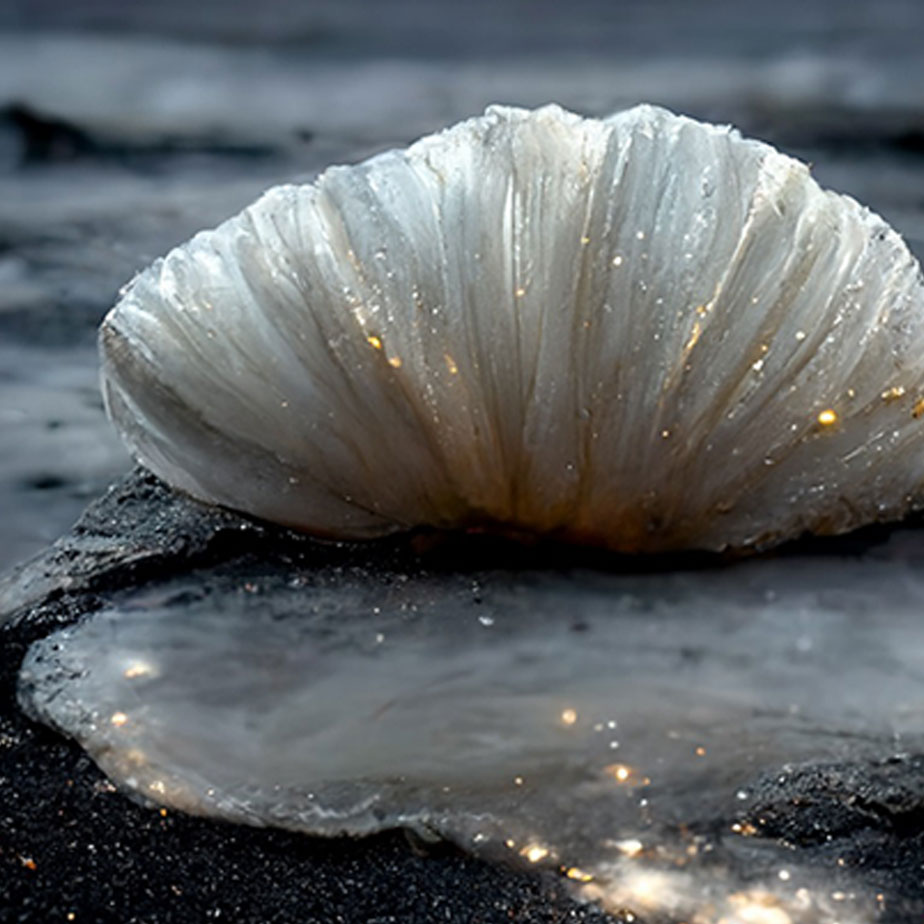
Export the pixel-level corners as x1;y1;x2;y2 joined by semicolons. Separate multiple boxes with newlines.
0;471;924;922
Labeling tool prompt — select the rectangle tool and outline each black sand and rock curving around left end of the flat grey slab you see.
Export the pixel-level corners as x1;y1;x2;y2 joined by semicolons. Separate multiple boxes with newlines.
0;472;628;924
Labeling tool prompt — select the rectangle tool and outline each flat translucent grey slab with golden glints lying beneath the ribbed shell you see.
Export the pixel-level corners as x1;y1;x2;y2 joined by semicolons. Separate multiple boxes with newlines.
21;533;924;924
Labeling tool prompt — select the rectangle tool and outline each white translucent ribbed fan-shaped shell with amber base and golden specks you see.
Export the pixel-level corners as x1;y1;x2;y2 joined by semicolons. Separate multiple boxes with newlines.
101;106;924;552
